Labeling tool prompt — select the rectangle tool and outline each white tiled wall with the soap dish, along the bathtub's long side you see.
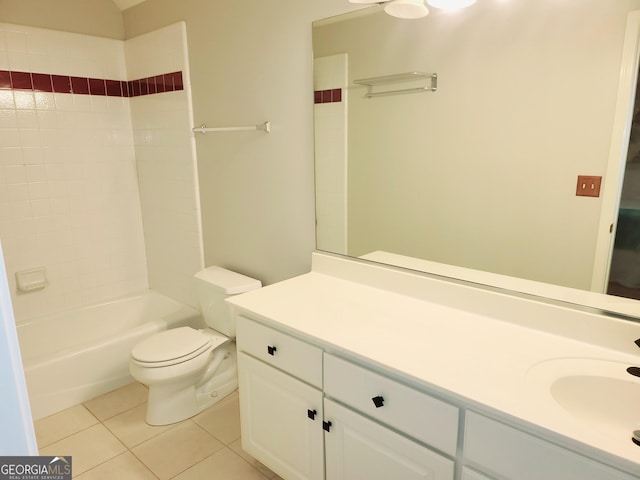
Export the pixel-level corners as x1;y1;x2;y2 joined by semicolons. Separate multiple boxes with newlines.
0;24;148;321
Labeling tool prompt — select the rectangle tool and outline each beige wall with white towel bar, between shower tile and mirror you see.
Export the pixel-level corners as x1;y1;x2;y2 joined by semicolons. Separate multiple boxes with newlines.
124;0;350;283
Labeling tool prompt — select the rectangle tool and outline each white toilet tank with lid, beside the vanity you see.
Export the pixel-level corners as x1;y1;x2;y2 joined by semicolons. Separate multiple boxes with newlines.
195;266;262;338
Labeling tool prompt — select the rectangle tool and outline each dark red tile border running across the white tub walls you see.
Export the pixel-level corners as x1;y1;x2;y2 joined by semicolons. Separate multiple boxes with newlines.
0;70;184;97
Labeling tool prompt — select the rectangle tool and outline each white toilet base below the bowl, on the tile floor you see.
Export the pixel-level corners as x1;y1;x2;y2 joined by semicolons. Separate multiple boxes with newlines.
146;344;238;425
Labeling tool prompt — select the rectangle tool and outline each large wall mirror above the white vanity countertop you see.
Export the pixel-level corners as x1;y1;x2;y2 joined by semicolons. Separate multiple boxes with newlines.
313;0;640;318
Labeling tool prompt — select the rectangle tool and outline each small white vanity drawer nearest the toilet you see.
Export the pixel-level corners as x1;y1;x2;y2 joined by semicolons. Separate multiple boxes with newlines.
236;315;322;388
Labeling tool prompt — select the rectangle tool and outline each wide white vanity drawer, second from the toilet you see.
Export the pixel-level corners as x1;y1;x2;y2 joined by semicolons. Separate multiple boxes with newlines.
324;354;458;456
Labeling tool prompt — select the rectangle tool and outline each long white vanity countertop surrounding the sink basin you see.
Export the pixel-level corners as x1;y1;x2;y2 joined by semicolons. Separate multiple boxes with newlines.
229;253;640;475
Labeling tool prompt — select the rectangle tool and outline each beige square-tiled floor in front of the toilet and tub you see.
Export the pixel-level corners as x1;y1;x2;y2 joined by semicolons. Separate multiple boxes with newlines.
35;383;281;480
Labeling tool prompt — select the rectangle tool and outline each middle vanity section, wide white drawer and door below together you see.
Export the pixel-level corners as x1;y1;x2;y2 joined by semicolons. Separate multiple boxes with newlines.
324;354;458;480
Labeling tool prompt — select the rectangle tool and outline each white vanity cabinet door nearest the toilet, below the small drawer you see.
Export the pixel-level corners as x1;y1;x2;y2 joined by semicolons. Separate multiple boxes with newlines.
238;352;324;480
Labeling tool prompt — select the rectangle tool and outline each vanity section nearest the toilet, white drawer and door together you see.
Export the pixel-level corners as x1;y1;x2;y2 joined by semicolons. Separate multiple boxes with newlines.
237;317;324;480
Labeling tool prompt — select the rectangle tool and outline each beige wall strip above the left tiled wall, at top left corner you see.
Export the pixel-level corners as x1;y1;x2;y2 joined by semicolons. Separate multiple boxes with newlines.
0;0;124;40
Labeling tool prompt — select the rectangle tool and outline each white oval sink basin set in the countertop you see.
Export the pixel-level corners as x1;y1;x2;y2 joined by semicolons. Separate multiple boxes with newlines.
526;358;640;441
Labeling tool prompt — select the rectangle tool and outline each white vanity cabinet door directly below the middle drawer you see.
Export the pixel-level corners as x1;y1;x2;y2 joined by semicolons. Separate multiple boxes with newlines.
324;399;453;480
